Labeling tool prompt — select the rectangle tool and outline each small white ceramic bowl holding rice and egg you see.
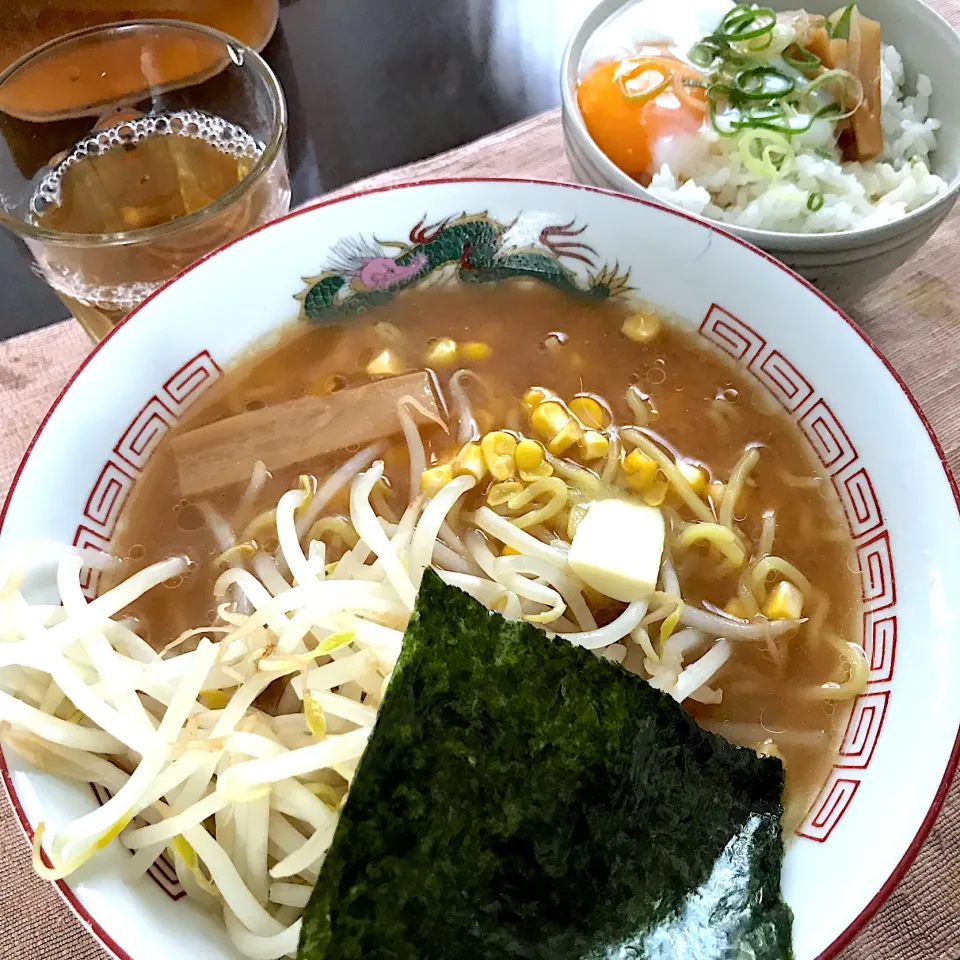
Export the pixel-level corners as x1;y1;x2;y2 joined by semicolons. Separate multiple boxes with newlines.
560;0;960;303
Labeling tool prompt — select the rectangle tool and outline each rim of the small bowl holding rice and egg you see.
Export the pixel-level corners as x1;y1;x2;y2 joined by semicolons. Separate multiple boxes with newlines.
560;0;960;252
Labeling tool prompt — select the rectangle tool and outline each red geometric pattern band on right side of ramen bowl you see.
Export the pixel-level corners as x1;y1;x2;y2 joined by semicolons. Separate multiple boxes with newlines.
700;304;897;843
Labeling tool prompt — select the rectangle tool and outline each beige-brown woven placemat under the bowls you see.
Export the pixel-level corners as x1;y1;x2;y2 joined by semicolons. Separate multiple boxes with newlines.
0;54;960;960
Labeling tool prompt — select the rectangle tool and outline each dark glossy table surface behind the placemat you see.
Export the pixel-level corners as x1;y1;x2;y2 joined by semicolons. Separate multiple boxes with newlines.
0;0;598;340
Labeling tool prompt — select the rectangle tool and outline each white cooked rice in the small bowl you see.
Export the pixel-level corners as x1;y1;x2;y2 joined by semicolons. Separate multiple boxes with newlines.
649;45;947;233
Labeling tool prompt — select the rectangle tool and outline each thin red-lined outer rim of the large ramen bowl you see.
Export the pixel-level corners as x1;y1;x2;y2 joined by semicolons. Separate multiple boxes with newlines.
0;176;960;960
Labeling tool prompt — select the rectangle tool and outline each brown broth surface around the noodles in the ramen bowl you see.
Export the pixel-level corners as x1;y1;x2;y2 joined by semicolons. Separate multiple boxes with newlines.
109;283;860;826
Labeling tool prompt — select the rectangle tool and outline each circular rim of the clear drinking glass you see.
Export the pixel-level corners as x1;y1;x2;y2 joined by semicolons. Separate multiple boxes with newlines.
0;17;287;247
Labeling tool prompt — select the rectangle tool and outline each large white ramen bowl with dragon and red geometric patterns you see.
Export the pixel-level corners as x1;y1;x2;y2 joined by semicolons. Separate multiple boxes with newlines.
0;180;960;960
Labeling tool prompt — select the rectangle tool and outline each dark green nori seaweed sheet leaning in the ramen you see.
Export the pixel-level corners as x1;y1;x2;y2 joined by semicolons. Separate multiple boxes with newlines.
298;571;793;960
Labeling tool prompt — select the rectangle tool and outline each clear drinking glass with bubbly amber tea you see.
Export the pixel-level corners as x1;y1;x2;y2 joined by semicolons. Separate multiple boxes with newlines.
0;20;290;340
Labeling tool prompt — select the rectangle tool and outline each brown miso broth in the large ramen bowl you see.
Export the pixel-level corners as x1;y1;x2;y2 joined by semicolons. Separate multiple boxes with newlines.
107;283;860;826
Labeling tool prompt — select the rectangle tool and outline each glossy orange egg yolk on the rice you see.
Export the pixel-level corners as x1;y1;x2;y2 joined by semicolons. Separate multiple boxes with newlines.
577;56;707;183
